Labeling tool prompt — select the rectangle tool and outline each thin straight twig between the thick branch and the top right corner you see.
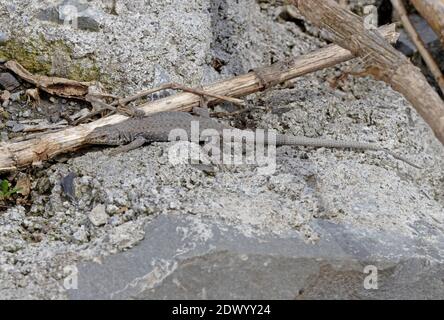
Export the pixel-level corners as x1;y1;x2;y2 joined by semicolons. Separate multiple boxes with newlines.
391;0;444;94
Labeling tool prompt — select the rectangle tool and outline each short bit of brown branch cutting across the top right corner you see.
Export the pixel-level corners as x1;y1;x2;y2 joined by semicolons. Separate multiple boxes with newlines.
412;0;444;45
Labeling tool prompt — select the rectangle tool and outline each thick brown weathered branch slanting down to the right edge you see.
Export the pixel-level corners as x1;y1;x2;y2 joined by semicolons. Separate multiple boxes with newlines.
293;0;444;143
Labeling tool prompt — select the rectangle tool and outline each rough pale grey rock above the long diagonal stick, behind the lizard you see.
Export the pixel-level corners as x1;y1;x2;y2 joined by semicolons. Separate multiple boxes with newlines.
4;0;298;96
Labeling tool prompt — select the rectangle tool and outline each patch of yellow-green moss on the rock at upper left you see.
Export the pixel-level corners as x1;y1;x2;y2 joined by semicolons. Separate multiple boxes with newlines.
0;37;100;81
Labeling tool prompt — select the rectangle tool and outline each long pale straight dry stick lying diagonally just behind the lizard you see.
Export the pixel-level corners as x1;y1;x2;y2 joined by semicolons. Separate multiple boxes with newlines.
0;25;398;172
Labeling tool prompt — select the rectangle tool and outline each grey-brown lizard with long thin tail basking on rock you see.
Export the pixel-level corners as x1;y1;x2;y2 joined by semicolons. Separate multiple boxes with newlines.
84;111;420;169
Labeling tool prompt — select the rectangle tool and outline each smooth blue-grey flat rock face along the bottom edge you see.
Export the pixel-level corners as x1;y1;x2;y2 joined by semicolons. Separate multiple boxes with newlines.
69;216;444;299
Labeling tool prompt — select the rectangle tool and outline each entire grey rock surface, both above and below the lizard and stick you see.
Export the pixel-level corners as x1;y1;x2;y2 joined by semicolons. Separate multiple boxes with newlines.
0;0;444;299
